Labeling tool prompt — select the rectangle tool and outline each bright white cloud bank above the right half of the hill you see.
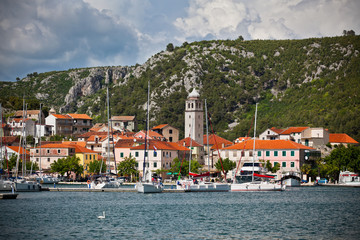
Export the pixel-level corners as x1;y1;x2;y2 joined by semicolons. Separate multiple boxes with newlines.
174;0;360;39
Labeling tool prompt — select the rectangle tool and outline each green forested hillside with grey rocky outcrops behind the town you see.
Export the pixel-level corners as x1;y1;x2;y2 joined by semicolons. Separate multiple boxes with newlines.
0;36;360;141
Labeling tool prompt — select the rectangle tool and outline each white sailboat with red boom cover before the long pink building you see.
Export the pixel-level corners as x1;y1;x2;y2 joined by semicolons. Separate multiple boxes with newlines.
230;103;286;192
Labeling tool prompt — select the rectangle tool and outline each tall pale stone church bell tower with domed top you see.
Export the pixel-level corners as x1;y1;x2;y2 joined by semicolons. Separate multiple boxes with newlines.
184;88;204;145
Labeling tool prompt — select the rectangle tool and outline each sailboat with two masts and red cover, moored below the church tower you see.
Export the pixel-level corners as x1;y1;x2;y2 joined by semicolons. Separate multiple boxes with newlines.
176;99;230;192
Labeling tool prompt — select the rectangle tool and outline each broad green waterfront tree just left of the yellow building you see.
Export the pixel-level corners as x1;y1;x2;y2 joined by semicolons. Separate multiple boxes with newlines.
50;155;84;178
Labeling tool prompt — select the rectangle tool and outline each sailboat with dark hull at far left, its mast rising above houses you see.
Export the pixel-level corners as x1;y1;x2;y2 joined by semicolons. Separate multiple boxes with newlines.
14;100;41;192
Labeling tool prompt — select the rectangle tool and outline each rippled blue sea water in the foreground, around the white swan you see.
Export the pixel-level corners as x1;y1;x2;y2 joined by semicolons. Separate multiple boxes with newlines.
0;187;360;239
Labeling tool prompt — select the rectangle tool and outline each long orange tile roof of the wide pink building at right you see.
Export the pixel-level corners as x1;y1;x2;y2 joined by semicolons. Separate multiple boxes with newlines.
222;139;315;150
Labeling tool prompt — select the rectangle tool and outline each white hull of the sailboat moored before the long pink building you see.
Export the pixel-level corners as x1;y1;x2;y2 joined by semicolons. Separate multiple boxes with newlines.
230;182;286;192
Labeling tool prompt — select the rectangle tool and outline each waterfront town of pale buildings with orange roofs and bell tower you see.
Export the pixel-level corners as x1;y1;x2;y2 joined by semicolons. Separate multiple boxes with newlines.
1;89;359;191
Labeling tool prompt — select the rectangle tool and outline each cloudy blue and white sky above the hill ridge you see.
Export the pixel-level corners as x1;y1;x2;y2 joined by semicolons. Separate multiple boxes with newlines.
0;0;360;81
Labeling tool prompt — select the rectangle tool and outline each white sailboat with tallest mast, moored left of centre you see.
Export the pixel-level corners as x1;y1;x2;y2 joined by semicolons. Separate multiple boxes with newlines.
91;87;122;189
